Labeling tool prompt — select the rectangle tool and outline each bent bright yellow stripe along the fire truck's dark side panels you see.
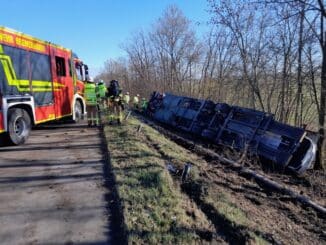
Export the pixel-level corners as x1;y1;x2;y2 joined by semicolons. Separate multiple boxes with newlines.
0;45;65;92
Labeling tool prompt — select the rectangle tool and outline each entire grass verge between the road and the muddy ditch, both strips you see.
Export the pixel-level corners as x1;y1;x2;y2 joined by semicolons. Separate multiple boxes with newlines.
105;118;265;244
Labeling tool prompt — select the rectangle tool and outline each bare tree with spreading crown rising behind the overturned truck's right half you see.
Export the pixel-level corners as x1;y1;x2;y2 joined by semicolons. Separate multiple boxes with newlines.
209;0;268;110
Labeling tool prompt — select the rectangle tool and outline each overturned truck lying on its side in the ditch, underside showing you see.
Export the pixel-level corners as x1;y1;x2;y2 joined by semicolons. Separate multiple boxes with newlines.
147;92;316;174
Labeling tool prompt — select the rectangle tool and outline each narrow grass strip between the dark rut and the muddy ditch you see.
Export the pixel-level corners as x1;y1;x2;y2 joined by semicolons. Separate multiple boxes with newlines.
136;117;268;244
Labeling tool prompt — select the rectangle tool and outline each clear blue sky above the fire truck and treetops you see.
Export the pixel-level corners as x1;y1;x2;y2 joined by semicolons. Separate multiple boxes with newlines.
0;0;209;75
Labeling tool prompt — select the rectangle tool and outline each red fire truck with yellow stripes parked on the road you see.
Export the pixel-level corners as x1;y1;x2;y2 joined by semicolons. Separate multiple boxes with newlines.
0;26;88;145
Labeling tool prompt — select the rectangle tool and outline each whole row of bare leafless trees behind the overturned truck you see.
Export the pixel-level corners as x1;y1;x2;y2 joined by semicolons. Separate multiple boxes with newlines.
96;0;326;168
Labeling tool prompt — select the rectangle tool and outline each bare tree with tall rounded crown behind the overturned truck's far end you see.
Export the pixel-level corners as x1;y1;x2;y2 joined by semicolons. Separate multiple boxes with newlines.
151;5;200;92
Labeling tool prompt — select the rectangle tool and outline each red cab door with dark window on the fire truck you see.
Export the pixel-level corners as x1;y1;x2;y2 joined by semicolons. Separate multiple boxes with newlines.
51;48;74;118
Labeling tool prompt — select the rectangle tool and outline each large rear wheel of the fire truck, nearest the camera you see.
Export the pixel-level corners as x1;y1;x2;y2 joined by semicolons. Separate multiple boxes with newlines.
8;108;31;145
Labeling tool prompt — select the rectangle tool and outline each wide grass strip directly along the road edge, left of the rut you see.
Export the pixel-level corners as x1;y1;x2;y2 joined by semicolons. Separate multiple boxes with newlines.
104;118;212;244
